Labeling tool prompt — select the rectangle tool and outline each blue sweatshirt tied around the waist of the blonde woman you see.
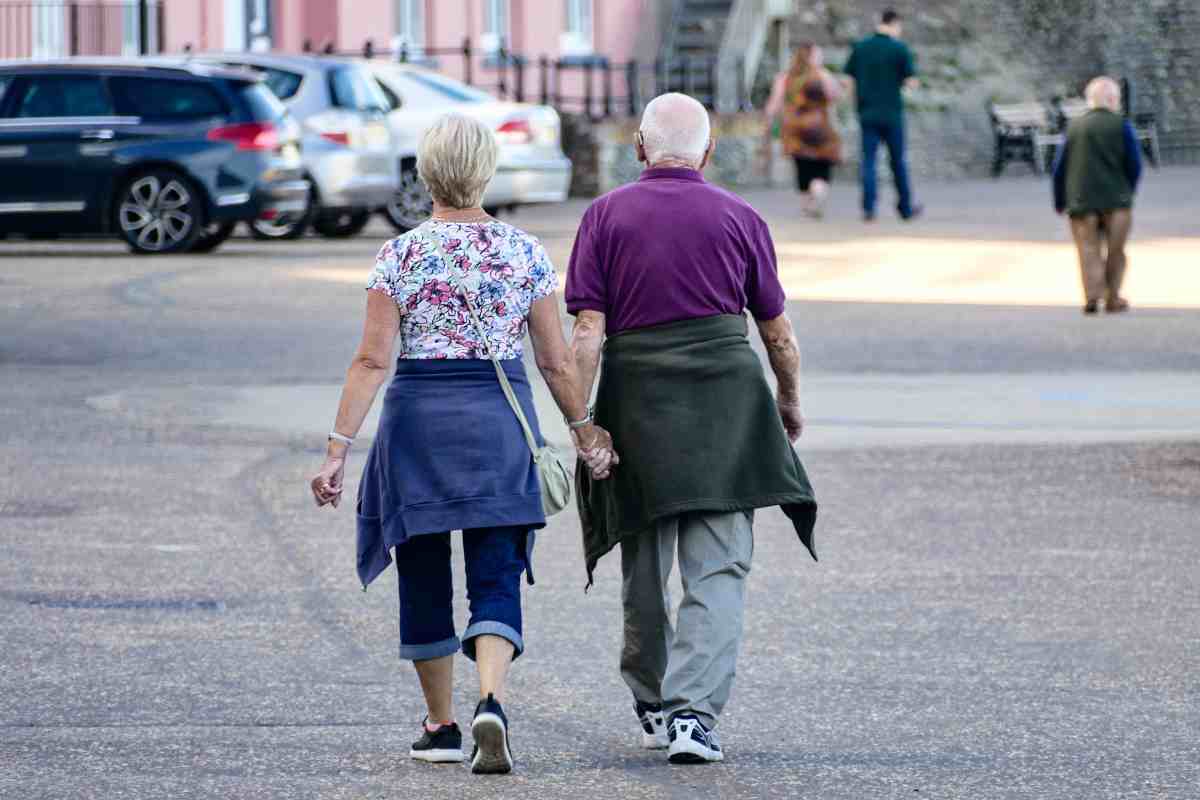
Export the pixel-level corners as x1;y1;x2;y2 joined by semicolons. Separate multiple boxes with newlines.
358;359;546;589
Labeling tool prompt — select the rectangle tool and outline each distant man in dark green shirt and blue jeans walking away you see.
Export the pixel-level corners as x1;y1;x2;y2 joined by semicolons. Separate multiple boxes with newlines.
845;8;922;222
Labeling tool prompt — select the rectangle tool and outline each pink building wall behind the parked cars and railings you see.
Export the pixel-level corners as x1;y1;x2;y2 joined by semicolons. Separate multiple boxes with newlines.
0;0;664;115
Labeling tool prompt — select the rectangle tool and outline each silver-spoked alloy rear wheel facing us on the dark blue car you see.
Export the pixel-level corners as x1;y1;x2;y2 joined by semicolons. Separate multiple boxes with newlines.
116;169;203;253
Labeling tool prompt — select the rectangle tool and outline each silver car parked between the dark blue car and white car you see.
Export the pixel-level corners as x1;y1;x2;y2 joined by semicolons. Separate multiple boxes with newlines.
194;53;400;239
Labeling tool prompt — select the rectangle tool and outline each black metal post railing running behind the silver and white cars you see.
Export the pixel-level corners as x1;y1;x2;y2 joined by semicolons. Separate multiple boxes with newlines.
304;38;750;120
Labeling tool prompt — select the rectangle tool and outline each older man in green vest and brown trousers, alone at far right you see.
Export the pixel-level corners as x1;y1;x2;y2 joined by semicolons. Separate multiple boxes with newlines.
1054;77;1141;314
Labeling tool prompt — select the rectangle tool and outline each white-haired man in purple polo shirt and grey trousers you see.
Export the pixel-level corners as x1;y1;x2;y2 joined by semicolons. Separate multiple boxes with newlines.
566;94;816;764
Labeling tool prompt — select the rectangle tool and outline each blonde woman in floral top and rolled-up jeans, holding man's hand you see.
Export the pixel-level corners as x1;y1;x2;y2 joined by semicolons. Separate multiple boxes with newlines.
312;114;617;772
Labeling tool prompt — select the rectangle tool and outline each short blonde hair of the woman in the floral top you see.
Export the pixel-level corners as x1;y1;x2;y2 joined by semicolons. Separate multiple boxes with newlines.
416;114;499;209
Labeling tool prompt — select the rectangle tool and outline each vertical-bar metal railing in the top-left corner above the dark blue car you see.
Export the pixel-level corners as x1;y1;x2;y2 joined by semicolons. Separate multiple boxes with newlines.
0;0;166;59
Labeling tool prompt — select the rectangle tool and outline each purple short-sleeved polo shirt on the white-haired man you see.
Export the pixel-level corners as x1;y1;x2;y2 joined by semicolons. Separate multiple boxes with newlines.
566;168;786;335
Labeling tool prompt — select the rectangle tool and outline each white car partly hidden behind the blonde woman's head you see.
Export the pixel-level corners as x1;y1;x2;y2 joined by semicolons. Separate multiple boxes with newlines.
362;61;571;233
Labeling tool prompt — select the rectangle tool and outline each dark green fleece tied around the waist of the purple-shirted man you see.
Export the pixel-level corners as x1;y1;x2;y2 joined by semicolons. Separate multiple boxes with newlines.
576;315;817;585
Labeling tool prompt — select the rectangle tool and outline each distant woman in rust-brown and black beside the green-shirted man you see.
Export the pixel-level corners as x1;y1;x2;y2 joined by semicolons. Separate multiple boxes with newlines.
767;43;842;218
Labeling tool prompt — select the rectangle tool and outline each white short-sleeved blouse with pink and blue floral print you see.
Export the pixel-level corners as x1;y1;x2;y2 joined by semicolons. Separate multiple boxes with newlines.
367;221;558;359
